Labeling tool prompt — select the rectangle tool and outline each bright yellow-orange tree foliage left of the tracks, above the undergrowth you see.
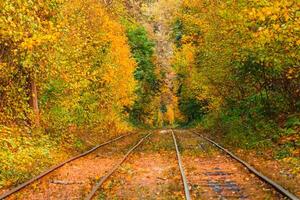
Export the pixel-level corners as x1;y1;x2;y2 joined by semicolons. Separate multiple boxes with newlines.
0;0;136;134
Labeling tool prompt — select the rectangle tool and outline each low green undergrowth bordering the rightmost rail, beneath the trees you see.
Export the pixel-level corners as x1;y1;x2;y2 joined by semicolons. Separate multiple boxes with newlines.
199;112;300;159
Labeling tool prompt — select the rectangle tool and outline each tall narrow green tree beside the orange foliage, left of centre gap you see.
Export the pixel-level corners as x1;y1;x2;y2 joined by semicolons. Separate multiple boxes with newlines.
127;24;159;125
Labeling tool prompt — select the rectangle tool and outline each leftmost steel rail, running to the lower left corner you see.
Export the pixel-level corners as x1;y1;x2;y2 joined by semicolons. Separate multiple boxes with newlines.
0;133;133;200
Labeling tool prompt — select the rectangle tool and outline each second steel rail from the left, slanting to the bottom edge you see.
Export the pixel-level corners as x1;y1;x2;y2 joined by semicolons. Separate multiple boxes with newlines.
85;133;152;200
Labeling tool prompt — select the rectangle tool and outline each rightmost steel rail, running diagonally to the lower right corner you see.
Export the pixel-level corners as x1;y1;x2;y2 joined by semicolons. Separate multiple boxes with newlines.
191;131;299;200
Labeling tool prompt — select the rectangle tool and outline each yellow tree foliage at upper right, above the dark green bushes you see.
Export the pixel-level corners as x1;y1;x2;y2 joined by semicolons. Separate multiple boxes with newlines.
173;0;300;114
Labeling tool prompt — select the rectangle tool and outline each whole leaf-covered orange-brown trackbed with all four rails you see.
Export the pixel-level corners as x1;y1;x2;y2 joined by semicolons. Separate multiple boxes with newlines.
0;129;298;200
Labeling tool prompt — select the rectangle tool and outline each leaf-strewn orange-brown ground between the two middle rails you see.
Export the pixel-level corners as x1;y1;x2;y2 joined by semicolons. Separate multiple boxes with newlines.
98;131;184;199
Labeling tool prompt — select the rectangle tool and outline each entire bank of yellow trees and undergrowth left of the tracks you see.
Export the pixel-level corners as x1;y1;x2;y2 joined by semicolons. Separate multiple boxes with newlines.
0;0;153;187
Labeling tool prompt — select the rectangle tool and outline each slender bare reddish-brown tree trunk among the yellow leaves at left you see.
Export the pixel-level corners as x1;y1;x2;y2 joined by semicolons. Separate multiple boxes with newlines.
30;78;40;127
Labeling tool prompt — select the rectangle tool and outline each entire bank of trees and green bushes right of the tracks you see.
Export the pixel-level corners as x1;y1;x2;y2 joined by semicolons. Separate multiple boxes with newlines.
173;0;300;174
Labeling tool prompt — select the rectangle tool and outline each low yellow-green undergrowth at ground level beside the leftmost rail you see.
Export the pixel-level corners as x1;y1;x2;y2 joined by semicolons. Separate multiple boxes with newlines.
0;126;80;188
